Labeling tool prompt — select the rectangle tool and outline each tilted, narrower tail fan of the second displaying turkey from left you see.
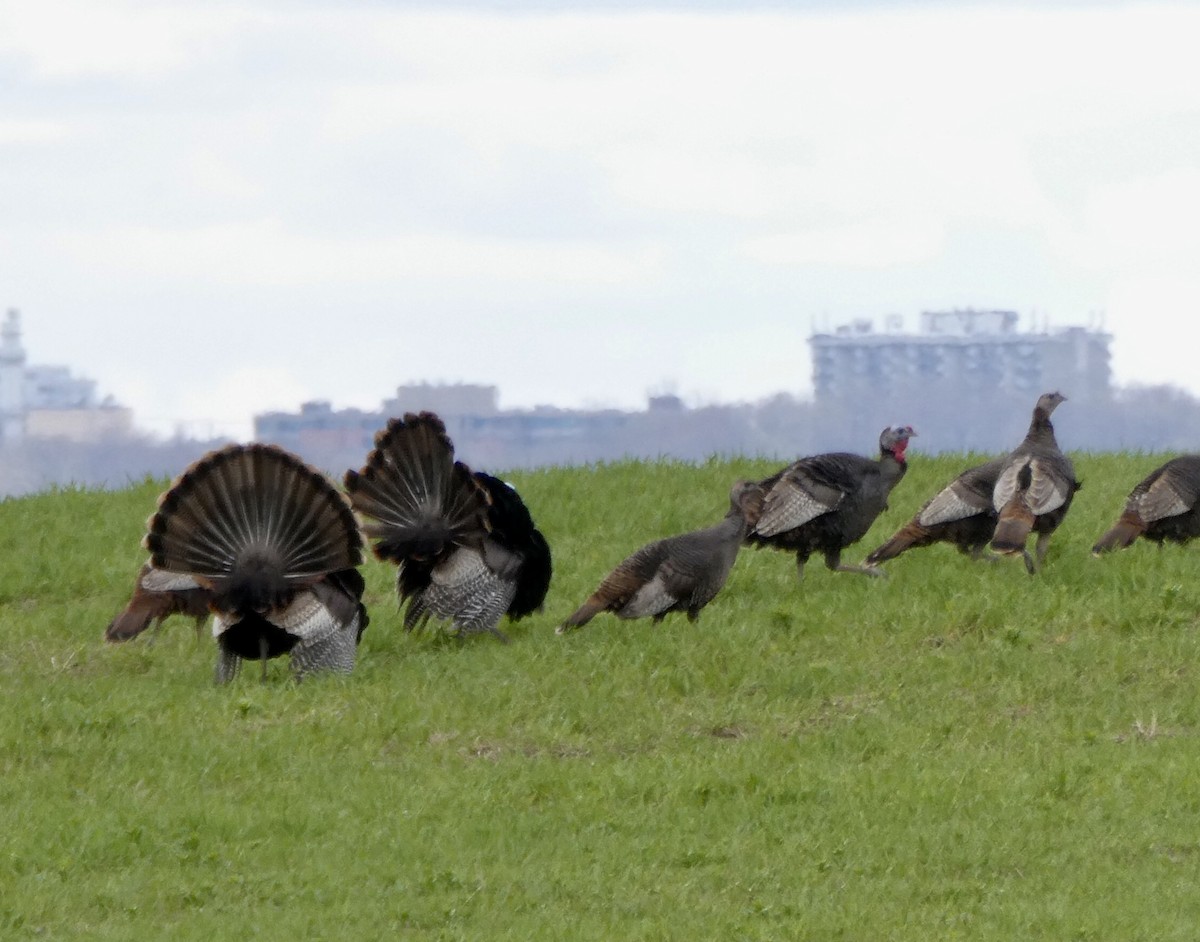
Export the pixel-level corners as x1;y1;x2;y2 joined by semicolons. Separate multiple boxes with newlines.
344;412;487;562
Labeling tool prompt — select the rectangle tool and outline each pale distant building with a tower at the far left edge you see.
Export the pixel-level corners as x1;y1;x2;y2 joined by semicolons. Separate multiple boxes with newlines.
0;308;133;444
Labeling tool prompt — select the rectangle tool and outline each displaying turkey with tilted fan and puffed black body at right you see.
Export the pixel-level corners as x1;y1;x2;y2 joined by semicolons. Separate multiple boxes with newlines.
346;412;551;641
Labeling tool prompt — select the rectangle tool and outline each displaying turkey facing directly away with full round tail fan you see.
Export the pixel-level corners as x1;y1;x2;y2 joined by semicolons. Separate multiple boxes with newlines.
144;444;367;683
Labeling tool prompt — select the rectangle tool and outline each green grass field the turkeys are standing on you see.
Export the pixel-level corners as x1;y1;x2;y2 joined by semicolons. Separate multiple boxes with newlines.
0;454;1200;941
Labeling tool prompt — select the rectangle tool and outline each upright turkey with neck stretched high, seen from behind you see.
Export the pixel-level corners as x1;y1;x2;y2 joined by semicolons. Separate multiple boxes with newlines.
991;392;1079;575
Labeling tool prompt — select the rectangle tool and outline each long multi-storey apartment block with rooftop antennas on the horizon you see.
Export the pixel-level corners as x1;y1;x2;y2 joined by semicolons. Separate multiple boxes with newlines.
809;310;1112;402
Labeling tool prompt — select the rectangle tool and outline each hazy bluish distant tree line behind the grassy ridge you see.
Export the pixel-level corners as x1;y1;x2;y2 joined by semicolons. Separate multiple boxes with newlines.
0;385;1200;496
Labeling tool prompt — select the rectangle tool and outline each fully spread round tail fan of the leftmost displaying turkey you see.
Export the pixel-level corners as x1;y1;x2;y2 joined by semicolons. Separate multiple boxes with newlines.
144;444;362;611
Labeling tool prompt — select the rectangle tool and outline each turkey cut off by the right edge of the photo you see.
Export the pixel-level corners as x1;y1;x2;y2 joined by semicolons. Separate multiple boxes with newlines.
1092;455;1200;556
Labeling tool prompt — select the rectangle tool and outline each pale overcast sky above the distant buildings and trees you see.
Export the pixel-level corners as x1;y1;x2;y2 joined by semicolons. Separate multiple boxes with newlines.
0;0;1200;437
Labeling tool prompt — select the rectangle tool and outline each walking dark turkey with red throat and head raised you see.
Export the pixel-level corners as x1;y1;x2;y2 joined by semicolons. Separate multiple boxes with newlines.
746;425;917;577
